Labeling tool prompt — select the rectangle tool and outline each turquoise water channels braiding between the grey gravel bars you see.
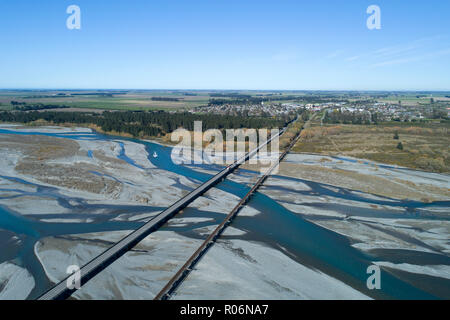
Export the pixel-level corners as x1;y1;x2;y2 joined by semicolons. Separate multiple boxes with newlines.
0;129;450;299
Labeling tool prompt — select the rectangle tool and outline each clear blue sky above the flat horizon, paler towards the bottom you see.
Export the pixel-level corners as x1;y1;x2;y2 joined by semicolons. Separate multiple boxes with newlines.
0;0;450;90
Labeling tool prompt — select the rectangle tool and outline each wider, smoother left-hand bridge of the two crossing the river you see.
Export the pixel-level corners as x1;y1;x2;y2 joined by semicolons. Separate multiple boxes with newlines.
38;123;300;300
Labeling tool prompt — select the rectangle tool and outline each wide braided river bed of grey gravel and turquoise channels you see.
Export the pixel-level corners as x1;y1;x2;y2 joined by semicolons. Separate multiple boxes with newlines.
0;125;450;299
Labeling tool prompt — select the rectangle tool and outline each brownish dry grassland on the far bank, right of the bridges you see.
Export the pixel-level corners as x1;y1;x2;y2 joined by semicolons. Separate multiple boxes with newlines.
293;125;450;172
